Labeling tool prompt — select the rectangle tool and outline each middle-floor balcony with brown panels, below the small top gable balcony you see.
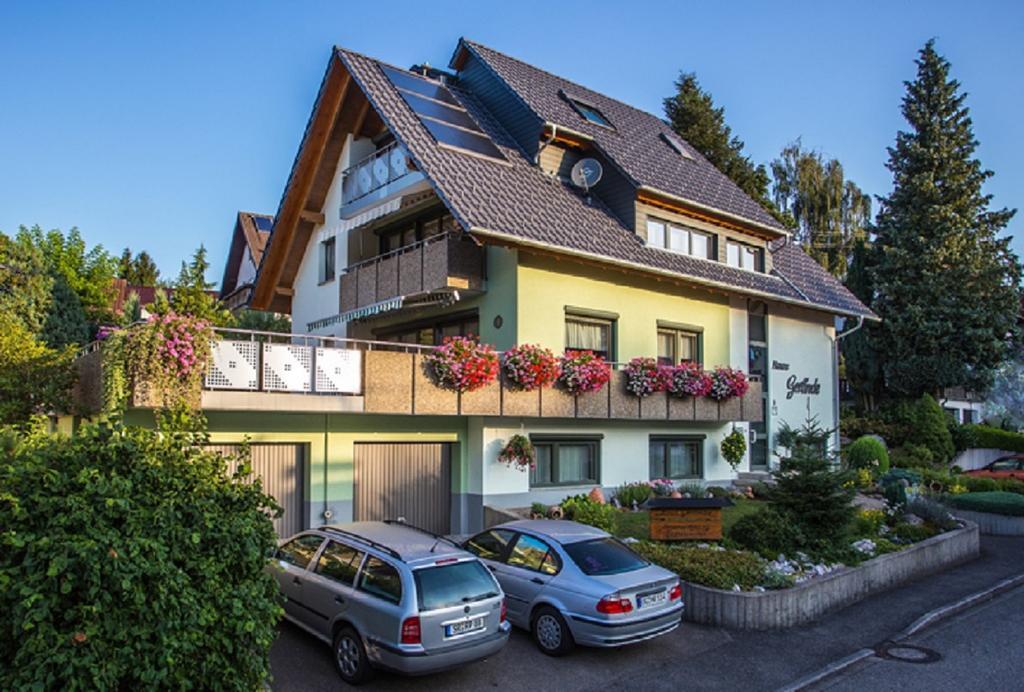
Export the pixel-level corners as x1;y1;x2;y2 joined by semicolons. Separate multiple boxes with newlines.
331;233;484;321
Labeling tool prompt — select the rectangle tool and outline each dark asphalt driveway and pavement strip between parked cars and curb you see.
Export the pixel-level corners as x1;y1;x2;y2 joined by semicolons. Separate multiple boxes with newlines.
270;536;1024;692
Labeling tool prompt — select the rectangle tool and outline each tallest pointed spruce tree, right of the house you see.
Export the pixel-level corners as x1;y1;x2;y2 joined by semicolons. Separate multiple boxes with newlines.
870;41;1020;397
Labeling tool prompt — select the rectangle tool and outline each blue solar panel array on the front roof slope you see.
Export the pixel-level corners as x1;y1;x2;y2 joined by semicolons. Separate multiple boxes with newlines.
381;66;505;159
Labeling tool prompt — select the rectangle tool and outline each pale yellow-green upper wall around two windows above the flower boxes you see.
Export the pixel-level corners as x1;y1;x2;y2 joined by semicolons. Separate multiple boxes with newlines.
517;254;729;366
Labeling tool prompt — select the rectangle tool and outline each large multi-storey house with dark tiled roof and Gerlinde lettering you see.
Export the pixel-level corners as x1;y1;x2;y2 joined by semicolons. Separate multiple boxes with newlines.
96;39;876;533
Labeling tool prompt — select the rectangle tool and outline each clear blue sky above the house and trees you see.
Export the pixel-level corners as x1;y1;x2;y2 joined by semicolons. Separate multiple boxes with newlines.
0;0;1024;280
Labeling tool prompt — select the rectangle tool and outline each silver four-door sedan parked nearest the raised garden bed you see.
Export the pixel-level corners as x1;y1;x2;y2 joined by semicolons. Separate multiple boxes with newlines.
464;519;683;656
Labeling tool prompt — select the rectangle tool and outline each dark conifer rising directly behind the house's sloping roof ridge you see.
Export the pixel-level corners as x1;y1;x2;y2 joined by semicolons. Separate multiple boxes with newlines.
664;73;780;218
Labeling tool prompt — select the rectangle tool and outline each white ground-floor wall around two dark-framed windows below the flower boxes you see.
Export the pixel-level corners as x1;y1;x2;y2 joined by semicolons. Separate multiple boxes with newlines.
469;418;745;507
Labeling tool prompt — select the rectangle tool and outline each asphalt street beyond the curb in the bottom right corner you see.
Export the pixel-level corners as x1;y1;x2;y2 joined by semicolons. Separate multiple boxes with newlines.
815;587;1024;692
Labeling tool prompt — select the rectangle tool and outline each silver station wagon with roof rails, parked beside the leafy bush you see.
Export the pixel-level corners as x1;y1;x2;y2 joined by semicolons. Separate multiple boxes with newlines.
269;522;511;684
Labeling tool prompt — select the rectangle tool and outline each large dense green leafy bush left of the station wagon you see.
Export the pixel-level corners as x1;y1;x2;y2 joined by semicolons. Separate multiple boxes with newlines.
0;425;282;690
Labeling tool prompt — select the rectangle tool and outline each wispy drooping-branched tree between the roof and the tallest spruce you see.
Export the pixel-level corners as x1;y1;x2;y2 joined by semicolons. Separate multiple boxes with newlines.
771;139;871;278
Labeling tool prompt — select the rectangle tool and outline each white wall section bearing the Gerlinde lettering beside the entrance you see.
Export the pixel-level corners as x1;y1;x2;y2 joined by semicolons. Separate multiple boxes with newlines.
766;304;839;458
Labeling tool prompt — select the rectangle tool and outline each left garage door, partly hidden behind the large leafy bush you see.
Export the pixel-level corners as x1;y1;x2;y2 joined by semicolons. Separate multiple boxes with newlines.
208;444;306;538
